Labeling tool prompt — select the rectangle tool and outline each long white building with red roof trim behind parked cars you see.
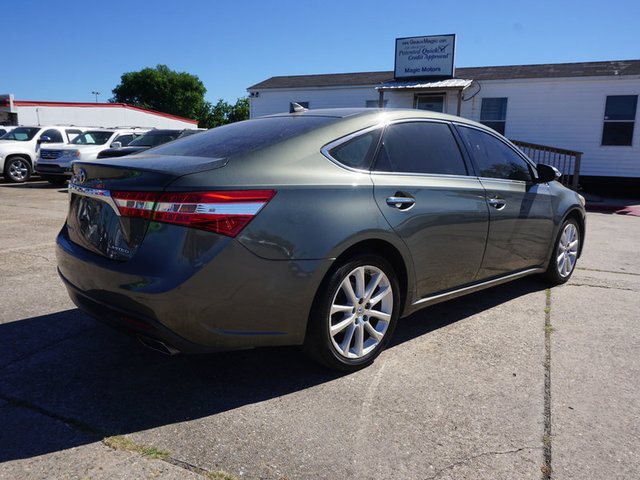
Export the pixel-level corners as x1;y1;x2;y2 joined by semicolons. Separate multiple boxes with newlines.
0;94;198;129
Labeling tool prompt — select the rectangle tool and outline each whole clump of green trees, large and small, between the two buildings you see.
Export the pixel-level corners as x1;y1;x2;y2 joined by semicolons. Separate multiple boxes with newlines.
109;65;249;128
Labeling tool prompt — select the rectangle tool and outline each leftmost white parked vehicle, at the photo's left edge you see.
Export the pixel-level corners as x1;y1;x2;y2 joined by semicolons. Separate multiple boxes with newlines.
0;125;82;183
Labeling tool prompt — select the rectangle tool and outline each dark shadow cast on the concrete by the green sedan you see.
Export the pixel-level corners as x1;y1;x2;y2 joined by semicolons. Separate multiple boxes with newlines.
0;279;545;462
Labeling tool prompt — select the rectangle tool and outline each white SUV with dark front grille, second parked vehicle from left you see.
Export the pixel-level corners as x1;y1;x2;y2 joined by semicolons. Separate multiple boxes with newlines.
35;128;149;184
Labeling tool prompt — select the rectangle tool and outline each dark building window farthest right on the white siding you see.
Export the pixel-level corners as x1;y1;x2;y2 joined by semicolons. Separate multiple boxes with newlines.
602;95;638;145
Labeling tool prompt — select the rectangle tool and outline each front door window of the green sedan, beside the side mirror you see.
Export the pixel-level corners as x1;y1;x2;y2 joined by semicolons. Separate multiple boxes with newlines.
459;126;532;182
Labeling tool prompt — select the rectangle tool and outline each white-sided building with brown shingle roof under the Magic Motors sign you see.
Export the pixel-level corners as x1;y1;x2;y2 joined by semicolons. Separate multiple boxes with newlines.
247;60;640;191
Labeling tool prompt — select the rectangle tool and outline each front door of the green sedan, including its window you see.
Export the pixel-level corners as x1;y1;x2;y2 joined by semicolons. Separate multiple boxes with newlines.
456;125;553;279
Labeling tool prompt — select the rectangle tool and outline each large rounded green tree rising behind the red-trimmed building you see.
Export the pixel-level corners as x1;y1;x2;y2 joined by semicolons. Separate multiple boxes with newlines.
110;65;207;120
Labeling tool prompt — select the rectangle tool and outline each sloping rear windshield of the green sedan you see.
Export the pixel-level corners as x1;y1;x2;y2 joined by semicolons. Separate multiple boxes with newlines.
147;116;338;158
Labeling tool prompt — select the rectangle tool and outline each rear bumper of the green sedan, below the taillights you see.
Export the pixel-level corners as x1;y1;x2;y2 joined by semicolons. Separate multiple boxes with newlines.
56;226;332;352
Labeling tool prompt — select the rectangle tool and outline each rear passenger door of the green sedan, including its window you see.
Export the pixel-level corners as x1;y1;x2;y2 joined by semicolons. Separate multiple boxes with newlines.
371;120;489;298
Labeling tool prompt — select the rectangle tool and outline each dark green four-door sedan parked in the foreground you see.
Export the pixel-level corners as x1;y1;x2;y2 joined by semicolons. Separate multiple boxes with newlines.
57;109;585;371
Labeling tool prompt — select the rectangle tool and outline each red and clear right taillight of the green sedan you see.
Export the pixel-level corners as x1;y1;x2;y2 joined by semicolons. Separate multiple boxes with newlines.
111;190;276;237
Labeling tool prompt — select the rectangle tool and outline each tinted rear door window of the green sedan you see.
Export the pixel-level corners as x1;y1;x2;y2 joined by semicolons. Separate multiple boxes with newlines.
375;122;467;175
